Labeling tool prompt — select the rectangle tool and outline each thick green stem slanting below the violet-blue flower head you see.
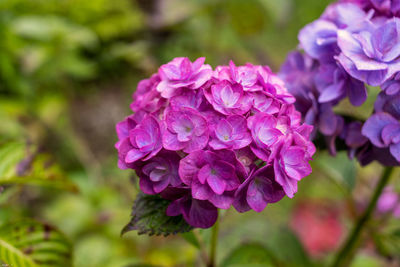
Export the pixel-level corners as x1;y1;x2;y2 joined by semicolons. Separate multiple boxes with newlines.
332;167;393;267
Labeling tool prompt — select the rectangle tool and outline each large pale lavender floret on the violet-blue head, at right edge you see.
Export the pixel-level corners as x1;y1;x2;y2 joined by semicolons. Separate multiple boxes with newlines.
337;18;400;86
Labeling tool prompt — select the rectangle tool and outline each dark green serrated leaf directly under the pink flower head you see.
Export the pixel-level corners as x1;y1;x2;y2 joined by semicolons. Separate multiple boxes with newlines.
121;193;192;236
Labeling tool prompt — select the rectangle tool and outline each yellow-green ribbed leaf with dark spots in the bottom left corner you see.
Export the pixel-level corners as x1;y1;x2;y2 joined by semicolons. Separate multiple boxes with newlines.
0;220;72;267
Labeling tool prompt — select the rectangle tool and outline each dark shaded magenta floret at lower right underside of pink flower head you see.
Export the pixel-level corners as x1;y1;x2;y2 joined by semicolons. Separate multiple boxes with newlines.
233;165;285;212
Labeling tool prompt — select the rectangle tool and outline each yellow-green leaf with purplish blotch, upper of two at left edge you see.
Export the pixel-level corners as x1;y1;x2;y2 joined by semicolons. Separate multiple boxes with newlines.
0;142;77;191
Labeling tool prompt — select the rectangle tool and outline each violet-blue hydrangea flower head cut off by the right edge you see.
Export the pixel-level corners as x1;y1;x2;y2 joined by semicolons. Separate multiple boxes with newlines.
280;0;400;165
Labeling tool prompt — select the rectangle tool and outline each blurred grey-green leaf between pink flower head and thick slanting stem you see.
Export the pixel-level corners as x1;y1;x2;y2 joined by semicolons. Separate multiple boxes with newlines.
315;151;357;192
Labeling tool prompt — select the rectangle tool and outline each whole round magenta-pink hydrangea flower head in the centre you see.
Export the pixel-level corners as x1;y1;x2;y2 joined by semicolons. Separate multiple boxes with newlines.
116;58;315;228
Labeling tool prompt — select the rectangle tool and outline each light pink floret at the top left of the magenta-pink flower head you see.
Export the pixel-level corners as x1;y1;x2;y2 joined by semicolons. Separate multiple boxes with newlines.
157;57;212;98
